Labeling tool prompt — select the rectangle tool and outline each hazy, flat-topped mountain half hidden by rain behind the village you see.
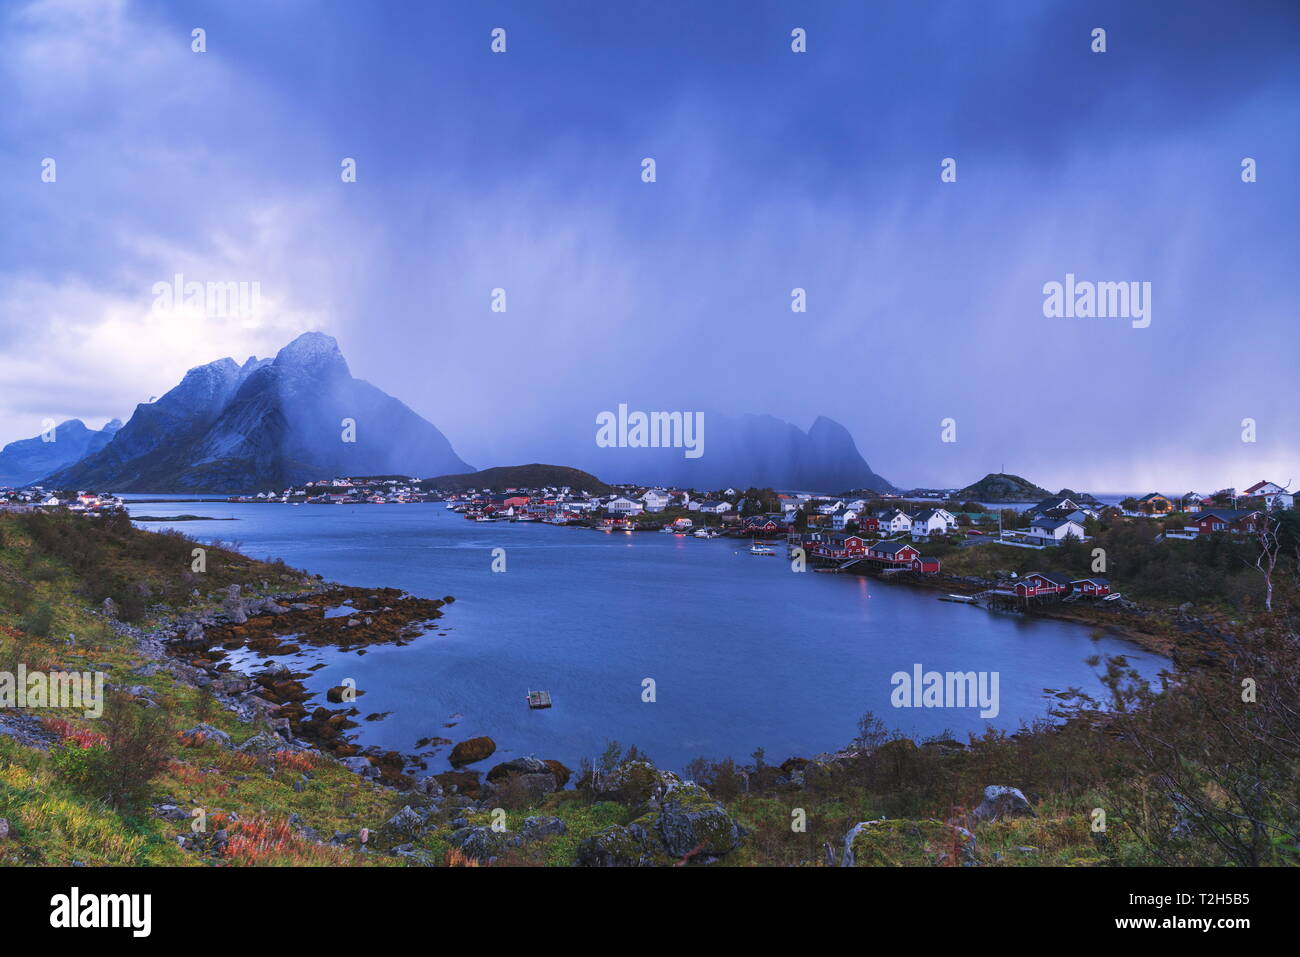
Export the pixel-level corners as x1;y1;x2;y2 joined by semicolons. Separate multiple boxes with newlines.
564;412;894;493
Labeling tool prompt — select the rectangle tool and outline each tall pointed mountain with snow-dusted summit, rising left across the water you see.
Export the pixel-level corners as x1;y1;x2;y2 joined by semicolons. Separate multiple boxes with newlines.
40;333;472;492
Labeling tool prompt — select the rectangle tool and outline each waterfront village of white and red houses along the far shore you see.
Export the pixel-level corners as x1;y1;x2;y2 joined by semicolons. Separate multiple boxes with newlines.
0;476;1295;606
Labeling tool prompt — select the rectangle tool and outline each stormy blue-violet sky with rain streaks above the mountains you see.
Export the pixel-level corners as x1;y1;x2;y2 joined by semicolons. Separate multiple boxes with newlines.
0;0;1300;493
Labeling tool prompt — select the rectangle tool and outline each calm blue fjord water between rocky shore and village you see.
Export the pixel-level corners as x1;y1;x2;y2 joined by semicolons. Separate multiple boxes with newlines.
131;497;1166;771
